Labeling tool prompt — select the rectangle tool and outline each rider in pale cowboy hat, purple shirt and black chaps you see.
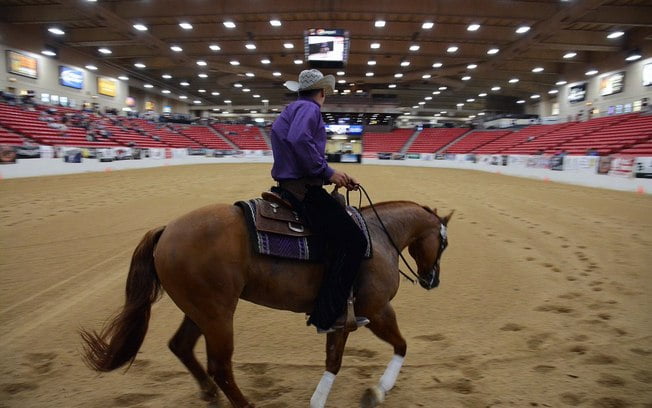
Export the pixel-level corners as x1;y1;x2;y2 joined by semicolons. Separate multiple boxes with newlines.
270;69;369;333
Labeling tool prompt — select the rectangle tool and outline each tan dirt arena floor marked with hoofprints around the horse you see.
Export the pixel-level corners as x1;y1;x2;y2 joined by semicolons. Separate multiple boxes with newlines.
0;164;652;408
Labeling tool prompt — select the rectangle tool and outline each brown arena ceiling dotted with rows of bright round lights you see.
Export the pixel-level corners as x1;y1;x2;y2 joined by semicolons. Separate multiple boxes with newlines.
0;0;652;114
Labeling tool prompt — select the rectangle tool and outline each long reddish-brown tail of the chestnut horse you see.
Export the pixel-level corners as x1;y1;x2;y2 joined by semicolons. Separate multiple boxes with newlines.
81;226;165;371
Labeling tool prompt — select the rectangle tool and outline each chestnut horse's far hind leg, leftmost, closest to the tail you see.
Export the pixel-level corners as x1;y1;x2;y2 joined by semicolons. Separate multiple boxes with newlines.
168;316;218;401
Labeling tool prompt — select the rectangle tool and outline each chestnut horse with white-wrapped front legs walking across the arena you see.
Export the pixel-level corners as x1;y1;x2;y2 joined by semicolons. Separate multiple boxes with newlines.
81;201;452;408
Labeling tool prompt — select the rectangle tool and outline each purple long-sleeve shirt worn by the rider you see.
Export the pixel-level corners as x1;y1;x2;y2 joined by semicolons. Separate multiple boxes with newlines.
270;98;334;181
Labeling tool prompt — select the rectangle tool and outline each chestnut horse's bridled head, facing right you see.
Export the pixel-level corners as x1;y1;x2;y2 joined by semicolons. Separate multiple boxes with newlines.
408;207;454;290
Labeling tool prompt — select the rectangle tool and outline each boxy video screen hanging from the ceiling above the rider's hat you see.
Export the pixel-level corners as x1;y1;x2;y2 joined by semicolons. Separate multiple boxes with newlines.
304;28;350;68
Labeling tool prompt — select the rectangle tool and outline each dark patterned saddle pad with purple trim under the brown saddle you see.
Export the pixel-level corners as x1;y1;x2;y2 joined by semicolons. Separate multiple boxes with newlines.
235;198;372;262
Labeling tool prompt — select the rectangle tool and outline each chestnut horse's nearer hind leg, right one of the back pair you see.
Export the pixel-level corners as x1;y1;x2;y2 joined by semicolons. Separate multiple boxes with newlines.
202;313;254;408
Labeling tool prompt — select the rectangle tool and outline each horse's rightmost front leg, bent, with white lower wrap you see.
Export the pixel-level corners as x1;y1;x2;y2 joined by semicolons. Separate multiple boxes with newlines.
360;303;407;408
